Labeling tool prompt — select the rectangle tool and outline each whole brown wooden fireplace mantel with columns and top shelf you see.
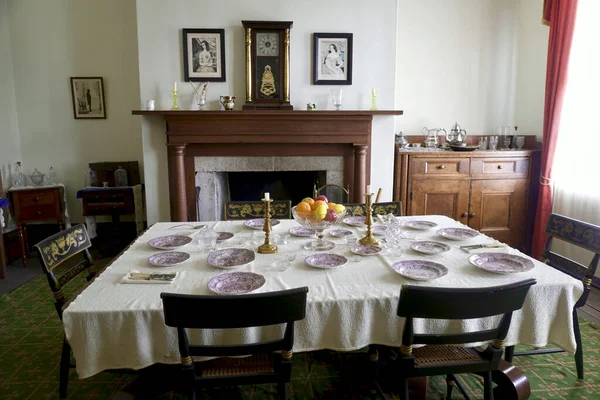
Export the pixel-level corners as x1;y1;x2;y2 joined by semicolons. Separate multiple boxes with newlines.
132;110;403;221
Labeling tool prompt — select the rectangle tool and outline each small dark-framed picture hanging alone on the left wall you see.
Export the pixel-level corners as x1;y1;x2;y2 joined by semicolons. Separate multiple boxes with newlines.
71;77;106;119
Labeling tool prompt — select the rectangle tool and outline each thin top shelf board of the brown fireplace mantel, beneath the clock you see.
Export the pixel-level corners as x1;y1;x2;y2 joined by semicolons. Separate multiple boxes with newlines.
131;110;404;118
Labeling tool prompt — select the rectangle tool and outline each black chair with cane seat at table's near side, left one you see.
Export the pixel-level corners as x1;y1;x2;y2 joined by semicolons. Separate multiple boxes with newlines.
160;287;308;399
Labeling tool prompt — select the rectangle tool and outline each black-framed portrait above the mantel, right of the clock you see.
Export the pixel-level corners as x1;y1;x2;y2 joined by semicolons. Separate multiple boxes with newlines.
313;33;352;85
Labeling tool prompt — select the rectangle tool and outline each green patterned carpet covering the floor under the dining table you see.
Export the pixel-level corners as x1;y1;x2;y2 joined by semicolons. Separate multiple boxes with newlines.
0;270;600;400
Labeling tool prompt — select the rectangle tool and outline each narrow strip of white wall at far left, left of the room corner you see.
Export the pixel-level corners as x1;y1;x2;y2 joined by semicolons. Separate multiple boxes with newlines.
0;0;21;189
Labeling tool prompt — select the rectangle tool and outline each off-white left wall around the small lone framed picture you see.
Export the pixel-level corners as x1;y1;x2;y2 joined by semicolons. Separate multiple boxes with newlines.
7;0;142;221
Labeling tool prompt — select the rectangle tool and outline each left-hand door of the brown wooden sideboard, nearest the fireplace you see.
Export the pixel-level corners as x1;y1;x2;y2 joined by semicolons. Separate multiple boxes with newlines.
410;179;469;220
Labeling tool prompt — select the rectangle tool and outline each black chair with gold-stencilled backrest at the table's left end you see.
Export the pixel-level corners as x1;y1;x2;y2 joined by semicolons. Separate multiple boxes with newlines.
33;224;96;399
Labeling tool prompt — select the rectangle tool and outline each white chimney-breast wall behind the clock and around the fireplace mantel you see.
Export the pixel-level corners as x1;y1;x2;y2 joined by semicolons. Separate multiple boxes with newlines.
137;0;396;223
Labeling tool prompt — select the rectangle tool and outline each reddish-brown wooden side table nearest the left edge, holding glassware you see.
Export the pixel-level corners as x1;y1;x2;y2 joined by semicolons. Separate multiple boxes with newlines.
8;186;65;267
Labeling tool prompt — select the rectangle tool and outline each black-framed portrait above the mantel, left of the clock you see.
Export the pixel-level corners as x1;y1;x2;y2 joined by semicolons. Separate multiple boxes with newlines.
183;29;225;82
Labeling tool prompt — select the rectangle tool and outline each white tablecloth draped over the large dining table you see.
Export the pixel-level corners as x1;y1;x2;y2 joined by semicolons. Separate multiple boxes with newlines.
63;216;583;378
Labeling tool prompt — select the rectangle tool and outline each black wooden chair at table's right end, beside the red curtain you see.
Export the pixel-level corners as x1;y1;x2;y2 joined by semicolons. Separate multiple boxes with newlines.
505;214;600;379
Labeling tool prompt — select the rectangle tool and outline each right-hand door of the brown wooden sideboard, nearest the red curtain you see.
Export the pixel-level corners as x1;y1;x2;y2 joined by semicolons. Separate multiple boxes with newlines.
469;179;528;248
